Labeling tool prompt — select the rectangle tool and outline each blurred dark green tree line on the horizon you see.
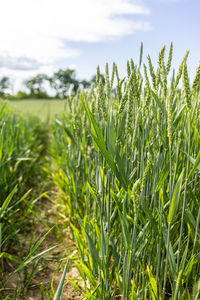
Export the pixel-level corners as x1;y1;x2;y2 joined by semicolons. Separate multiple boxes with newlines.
0;69;104;99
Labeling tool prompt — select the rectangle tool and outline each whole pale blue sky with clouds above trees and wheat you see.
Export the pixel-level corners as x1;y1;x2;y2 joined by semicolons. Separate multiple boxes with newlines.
0;0;200;89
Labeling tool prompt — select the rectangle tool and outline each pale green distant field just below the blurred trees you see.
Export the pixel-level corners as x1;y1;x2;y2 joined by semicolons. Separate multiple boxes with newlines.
8;99;66;121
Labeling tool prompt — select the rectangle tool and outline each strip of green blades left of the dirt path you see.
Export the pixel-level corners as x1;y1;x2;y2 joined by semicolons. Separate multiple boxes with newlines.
0;102;52;299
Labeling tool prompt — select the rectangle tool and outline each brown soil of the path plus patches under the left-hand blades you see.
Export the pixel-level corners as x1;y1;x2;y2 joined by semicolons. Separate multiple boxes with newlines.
2;193;81;300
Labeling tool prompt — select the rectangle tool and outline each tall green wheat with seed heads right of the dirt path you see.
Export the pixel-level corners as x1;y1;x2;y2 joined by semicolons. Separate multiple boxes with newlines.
52;45;200;299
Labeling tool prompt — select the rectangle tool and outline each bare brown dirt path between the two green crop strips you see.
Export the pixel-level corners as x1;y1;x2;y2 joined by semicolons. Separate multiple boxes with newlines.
25;195;81;300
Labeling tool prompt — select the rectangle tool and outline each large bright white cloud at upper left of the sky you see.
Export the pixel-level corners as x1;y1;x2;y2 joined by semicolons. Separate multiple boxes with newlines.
0;0;151;78
